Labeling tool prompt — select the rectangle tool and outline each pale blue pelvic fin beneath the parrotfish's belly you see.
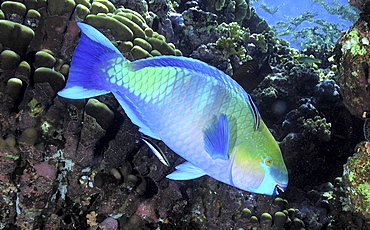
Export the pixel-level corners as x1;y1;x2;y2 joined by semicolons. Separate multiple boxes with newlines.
166;161;206;180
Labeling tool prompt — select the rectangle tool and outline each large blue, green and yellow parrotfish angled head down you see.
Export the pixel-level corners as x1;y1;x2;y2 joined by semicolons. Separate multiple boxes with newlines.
58;23;288;195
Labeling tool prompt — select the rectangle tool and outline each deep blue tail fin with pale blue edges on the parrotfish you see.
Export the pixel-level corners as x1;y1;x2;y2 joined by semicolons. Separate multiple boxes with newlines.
58;22;125;99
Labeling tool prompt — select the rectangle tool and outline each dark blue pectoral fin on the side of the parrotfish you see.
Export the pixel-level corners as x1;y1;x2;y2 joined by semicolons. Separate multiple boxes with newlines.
204;113;230;160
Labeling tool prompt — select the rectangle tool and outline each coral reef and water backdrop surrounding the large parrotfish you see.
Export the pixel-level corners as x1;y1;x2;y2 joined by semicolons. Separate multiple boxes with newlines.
0;0;370;229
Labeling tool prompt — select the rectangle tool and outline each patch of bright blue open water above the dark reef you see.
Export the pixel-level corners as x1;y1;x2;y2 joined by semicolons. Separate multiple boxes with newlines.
251;0;358;49
